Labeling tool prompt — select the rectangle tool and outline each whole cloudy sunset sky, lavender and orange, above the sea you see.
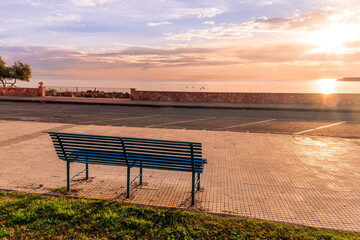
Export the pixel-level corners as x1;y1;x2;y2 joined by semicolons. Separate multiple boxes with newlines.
0;0;360;85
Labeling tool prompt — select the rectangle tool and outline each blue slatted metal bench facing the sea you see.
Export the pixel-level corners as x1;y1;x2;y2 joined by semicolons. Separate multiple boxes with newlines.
46;132;206;205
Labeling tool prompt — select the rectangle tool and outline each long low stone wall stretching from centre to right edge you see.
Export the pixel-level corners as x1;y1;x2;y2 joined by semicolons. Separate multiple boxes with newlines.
130;88;360;106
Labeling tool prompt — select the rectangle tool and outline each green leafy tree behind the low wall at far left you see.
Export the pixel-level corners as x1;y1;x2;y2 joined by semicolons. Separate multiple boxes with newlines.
0;57;31;87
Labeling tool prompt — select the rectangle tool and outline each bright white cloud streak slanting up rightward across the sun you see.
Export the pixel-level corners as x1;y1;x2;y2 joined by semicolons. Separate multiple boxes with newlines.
165;9;360;41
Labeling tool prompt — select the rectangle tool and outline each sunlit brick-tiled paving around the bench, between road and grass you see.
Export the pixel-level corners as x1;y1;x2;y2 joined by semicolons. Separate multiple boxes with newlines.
0;121;360;231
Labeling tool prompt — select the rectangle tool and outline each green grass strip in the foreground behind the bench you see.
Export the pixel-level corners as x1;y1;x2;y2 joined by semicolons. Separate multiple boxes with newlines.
0;191;360;239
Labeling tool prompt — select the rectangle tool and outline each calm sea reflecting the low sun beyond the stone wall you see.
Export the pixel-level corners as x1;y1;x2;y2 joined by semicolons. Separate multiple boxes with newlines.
17;79;360;93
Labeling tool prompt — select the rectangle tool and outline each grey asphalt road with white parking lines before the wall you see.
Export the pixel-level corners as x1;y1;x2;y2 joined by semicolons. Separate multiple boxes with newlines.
0;102;360;138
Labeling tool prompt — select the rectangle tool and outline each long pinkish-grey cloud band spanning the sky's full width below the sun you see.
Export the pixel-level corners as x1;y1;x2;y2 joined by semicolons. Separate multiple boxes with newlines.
4;42;354;68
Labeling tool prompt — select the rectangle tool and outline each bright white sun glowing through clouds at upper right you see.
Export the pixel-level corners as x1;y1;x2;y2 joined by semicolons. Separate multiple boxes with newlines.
305;24;359;53
